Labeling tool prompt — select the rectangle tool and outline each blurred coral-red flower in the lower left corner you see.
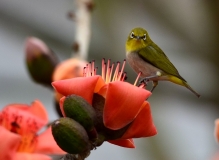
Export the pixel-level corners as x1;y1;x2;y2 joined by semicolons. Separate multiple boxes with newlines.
0;100;65;160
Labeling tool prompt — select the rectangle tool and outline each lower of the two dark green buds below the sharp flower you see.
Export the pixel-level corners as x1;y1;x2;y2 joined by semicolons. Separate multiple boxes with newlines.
52;117;92;154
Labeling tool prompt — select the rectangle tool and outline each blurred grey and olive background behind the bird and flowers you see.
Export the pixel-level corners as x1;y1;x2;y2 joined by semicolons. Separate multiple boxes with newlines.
0;0;219;160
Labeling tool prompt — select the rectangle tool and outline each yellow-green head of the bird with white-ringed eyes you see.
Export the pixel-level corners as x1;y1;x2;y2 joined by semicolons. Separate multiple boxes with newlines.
126;28;151;51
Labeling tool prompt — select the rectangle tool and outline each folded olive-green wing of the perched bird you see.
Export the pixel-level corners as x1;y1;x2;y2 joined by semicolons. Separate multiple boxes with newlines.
138;44;186;82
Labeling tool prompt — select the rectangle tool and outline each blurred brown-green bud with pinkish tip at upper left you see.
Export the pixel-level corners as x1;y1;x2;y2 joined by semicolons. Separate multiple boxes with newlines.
25;37;58;87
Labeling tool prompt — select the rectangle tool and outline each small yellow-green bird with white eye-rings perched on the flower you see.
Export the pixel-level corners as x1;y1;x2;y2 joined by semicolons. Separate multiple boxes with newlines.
126;28;200;97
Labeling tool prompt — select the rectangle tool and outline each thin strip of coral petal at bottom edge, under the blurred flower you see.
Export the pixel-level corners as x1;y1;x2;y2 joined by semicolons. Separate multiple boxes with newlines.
13;152;52;160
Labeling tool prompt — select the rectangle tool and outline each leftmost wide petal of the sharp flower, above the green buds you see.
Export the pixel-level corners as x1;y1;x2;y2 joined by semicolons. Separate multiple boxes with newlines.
52;76;104;104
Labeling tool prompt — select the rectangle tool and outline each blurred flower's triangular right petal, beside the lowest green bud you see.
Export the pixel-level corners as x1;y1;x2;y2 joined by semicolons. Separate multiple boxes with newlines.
34;127;66;154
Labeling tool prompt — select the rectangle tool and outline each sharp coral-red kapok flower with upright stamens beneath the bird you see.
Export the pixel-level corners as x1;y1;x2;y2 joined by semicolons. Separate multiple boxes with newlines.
52;60;157;148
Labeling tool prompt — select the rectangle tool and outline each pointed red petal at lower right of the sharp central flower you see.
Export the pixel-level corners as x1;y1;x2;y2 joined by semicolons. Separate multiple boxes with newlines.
122;101;157;139
